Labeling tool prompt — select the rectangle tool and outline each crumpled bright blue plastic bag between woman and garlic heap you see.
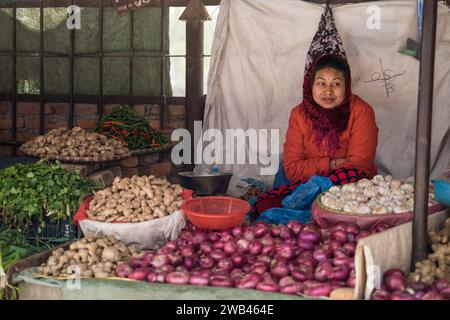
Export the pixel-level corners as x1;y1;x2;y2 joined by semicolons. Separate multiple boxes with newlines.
281;176;333;210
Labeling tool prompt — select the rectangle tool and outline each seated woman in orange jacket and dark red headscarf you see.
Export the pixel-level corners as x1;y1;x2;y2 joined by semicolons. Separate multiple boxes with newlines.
256;54;378;213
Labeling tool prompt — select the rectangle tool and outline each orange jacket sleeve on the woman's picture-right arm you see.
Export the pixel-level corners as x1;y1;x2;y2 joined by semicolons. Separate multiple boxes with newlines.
341;97;378;177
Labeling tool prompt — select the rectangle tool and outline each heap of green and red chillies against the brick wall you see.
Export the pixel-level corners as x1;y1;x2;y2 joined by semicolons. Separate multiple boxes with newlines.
95;106;169;150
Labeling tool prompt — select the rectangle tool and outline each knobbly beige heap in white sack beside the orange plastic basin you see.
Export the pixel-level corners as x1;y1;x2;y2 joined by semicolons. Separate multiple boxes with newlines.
86;175;183;222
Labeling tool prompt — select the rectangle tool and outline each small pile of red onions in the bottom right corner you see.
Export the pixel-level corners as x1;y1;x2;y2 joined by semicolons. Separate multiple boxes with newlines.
371;269;450;300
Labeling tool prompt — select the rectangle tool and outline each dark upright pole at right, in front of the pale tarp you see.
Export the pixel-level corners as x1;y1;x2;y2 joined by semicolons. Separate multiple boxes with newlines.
411;1;437;269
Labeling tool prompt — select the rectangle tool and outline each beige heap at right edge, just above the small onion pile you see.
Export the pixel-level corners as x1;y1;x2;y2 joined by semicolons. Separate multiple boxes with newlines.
409;218;450;284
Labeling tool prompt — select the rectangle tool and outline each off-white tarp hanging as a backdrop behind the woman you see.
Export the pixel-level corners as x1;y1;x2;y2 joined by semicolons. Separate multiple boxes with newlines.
196;0;450;192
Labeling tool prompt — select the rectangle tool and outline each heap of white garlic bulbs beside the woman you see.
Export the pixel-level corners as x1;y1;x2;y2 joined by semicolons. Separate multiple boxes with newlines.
320;175;435;215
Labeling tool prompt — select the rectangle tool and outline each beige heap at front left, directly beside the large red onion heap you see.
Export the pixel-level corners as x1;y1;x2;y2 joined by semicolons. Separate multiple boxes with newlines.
38;236;142;278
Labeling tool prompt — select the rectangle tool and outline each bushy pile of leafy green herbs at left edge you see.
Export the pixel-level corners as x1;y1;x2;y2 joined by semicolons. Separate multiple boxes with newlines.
0;160;96;232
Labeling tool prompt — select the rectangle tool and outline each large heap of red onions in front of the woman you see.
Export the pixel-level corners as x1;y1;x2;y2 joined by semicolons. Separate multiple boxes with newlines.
116;221;376;296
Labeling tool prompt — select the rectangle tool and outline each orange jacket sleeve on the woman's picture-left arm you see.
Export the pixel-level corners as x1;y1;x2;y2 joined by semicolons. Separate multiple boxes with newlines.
283;107;330;182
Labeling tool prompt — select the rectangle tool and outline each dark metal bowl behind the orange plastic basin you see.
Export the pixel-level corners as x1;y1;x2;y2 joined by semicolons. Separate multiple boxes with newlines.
177;171;233;196
